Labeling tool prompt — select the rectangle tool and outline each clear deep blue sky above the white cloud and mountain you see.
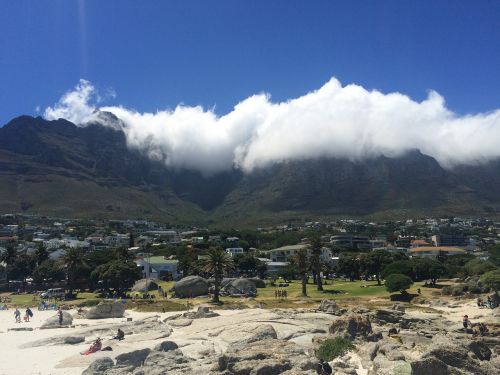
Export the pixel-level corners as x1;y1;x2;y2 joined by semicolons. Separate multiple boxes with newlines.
0;0;500;124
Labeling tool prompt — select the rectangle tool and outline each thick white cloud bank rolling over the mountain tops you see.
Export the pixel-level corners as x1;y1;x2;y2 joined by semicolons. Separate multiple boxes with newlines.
44;78;500;175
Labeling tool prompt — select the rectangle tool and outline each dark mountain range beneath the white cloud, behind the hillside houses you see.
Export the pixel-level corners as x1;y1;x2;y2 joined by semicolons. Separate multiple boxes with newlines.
0;113;500;226
